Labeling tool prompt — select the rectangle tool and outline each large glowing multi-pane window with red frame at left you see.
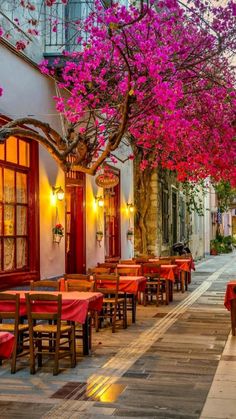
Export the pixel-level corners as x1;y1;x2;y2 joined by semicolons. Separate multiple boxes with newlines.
0;136;39;285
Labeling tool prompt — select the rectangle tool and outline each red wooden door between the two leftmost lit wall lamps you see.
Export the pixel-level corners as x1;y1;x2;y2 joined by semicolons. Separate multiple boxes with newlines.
66;183;86;273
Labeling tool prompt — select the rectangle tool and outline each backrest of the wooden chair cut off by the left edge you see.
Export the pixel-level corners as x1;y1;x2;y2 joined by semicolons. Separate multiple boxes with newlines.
0;292;20;330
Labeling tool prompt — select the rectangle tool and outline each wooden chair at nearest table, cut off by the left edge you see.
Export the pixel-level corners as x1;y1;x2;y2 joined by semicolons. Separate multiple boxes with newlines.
0;293;29;374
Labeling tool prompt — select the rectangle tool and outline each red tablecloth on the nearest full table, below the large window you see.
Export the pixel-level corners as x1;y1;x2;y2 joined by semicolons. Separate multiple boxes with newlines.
0;291;103;323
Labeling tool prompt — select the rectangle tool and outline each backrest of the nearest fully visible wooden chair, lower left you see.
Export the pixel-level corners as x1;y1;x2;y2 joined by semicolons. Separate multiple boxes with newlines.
25;292;62;330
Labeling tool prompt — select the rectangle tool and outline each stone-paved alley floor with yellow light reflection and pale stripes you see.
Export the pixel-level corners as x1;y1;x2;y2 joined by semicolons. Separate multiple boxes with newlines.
0;254;236;419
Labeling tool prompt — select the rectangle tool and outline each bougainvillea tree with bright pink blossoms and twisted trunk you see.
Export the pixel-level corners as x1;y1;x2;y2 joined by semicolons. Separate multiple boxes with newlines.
0;0;236;182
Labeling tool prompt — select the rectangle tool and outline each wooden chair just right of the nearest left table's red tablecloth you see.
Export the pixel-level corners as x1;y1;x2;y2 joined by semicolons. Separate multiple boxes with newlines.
94;275;127;333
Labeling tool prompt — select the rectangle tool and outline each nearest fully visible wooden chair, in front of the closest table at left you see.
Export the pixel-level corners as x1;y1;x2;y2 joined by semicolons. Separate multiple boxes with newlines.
25;293;76;375
